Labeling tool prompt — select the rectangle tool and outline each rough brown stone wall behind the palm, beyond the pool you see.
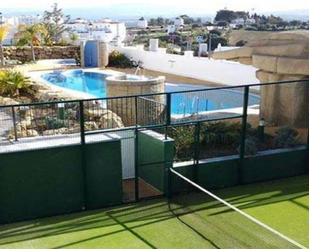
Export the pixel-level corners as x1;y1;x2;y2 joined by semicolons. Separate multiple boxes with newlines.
4;46;80;62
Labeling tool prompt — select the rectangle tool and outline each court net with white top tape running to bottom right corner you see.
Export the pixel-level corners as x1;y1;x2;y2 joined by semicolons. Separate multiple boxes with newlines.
169;168;306;249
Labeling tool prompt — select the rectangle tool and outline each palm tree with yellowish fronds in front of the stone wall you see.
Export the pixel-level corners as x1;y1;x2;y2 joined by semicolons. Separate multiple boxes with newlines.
17;24;46;61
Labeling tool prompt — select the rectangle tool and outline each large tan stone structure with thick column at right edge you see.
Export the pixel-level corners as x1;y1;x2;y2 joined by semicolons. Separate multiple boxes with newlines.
213;31;309;128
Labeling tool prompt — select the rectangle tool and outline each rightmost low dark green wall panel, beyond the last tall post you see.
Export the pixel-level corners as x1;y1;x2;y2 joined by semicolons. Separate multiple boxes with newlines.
242;148;308;183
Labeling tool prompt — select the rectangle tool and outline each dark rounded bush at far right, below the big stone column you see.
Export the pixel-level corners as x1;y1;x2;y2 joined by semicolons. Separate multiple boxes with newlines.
274;126;299;148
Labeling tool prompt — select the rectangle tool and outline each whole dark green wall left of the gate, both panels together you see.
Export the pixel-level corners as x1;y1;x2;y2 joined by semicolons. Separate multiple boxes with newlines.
0;140;122;223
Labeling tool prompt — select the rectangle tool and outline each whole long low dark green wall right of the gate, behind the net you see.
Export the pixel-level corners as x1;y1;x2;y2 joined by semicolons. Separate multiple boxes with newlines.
172;148;309;192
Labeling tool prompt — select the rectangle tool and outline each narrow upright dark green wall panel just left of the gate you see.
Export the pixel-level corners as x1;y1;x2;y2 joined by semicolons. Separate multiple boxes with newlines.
85;140;122;209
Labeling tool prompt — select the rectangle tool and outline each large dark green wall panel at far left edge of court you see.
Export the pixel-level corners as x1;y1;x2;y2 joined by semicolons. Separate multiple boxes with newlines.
0;146;83;223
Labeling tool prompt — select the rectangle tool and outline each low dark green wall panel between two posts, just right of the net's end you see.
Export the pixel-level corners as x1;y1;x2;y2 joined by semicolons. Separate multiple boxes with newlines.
197;157;239;189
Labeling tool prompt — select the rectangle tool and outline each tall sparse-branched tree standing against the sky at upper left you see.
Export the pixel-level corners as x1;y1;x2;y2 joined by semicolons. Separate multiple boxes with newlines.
43;3;70;45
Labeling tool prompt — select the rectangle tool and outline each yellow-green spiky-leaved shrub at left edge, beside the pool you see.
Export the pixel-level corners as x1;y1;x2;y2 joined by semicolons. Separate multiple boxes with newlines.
0;70;31;97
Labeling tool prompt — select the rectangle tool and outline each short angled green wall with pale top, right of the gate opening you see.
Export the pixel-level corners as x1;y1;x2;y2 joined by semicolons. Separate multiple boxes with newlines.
138;132;174;193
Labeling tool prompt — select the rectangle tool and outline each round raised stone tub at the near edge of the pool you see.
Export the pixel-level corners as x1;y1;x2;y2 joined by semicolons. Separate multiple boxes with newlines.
106;75;165;126
